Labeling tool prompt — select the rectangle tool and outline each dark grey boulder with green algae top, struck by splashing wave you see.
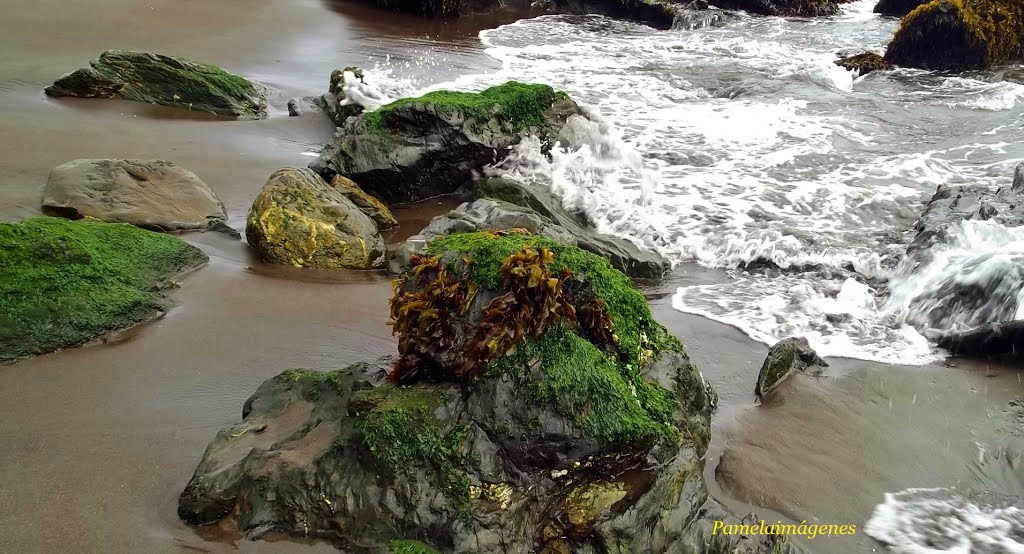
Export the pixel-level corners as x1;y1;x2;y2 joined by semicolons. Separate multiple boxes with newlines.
310;81;580;205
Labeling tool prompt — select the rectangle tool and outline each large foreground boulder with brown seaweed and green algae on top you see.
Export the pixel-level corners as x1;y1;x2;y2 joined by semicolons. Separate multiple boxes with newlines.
178;232;790;554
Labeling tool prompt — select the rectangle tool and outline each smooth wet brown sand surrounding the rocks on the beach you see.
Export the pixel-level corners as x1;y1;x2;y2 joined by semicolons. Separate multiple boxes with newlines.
0;0;1024;552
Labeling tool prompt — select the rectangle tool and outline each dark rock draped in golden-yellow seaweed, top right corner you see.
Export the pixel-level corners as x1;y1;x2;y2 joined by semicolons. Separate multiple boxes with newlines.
885;0;1024;72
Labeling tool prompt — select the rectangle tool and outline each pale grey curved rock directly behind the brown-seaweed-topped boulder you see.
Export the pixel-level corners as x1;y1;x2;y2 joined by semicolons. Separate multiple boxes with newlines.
388;199;577;273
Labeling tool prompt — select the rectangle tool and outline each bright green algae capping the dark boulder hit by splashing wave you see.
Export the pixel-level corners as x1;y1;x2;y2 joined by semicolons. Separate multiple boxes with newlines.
364;81;567;134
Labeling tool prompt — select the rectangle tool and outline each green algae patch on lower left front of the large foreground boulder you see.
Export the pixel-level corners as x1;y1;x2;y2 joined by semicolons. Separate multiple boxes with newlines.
349;385;470;517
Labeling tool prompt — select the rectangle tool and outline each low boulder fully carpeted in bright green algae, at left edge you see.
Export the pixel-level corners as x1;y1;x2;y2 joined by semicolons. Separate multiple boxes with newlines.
0;217;207;361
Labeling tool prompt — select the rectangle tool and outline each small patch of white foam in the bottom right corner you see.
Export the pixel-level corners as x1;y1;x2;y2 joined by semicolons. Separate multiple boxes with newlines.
864;488;1024;554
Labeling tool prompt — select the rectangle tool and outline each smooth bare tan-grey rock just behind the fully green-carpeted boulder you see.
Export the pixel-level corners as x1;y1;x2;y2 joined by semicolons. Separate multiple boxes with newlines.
43;160;227;231
